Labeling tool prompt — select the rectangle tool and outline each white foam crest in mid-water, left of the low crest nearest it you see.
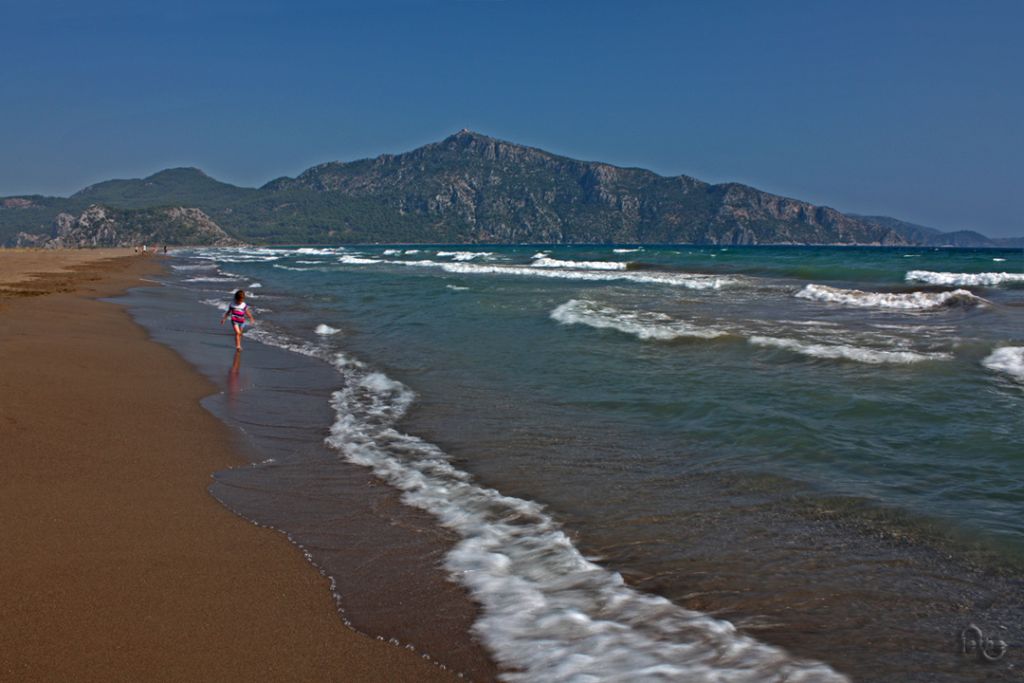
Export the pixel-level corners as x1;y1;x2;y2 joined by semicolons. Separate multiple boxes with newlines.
551;299;728;341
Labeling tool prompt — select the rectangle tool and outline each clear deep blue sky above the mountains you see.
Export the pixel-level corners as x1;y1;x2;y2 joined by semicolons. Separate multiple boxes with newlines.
0;0;1024;237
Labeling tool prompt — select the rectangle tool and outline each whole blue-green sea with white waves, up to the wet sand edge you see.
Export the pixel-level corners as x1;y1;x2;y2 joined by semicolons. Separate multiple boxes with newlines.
119;245;1024;683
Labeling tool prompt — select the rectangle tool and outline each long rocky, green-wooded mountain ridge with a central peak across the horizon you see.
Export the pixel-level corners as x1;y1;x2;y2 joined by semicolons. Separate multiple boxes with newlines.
0;130;1019;246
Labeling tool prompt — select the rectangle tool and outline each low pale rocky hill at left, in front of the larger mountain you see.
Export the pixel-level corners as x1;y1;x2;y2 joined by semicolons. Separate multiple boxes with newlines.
42;205;238;249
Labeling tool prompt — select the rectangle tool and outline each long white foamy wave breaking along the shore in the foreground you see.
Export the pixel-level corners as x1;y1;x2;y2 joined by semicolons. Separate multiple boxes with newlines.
230;330;848;683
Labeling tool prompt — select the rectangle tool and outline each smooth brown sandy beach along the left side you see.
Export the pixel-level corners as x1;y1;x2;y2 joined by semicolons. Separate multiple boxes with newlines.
0;250;454;681
